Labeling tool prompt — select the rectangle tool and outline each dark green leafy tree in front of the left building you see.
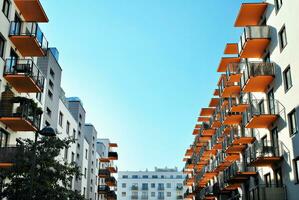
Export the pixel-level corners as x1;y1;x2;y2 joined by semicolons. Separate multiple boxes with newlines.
0;137;85;200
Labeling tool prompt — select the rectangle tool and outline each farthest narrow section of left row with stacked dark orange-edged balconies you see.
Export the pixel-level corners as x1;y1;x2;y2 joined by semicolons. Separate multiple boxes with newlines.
96;139;118;200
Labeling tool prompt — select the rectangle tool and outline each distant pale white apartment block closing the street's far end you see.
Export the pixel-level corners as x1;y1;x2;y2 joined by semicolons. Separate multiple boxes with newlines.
117;168;185;200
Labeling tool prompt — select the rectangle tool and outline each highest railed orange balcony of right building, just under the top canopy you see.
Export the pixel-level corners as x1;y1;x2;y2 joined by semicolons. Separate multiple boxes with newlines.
239;26;271;58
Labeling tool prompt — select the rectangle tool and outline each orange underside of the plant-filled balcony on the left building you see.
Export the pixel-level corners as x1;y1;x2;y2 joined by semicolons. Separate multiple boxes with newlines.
0;117;38;131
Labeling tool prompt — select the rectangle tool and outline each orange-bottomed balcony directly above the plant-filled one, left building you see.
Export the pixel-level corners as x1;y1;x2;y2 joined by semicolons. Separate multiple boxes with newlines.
3;58;45;93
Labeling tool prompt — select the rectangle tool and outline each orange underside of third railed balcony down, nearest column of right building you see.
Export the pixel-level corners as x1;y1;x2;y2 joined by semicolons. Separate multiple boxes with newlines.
246;115;278;128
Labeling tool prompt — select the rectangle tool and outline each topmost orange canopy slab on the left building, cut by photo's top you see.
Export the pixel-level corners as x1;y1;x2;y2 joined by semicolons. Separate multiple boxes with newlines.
14;0;49;22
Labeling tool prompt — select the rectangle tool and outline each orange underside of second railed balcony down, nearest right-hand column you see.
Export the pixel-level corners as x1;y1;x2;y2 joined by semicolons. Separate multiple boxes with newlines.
242;76;274;92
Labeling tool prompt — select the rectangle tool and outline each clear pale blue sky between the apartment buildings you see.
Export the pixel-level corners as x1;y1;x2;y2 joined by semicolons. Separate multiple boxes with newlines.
41;0;258;170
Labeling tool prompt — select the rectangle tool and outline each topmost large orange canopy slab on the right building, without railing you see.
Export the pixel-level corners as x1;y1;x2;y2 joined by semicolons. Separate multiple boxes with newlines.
235;3;268;27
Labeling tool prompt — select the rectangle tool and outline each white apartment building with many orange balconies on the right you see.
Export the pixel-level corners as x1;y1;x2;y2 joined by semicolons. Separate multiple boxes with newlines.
184;0;299;200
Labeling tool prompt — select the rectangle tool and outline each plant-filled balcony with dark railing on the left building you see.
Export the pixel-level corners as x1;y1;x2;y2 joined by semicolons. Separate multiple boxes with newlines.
0;96;43;131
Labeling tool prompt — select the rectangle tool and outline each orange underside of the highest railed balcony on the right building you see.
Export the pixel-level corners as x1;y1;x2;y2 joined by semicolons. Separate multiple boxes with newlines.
240;38;270;58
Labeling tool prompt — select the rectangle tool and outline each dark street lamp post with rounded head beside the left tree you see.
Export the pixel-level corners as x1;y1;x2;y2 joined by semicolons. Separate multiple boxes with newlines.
29;126;56;199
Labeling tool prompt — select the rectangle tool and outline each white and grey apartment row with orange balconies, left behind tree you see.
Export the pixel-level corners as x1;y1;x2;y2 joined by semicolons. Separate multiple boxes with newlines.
0;0;117;200
